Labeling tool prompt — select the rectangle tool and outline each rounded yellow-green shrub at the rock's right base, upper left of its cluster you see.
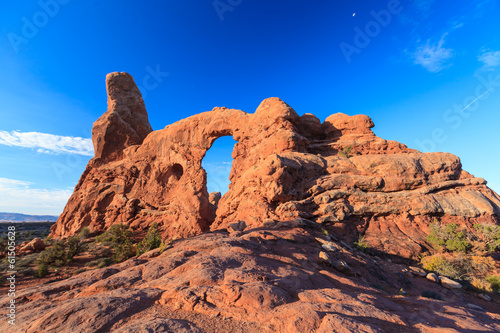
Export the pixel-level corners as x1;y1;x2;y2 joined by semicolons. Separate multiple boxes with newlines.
427;219;472;253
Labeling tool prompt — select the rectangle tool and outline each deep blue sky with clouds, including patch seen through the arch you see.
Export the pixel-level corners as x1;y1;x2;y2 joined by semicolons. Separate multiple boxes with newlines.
0;0;500;215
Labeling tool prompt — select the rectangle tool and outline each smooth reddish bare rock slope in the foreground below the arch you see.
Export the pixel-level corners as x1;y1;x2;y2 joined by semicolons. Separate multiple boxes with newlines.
4;227;500;333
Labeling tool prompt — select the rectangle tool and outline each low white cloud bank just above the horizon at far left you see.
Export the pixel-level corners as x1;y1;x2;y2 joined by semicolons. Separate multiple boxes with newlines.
0;178;73;215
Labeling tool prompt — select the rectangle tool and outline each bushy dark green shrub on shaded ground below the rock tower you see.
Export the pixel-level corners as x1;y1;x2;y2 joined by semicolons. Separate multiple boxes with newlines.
96;224;134;262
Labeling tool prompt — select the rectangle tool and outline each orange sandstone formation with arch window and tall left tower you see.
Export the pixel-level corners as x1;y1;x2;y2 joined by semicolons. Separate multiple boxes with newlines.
52;73;500;257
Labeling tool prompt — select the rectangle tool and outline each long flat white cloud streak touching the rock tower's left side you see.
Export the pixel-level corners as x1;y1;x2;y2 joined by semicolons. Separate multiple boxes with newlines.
0;131;94;156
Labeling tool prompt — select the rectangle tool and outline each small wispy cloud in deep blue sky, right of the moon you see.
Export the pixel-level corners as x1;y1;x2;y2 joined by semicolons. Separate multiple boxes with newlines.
413;34;453;73
